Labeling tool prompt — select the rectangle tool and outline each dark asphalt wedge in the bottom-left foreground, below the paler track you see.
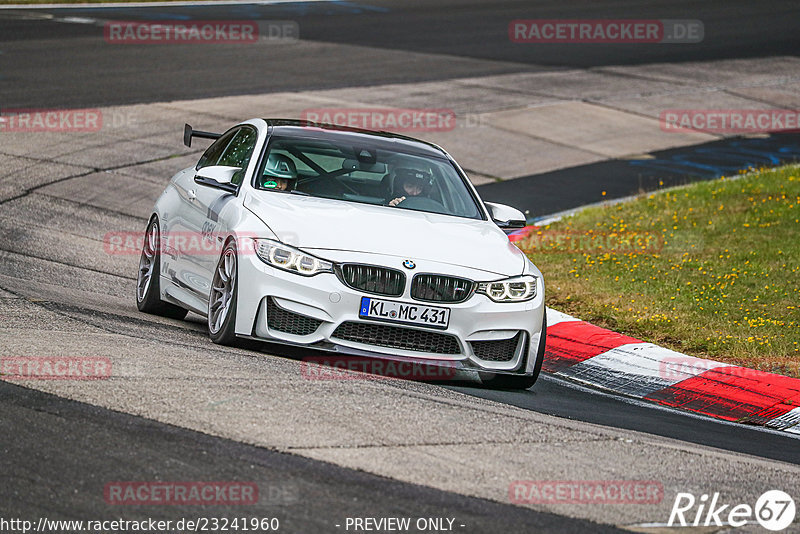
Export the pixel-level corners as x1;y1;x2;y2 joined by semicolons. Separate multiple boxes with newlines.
0;383;618;533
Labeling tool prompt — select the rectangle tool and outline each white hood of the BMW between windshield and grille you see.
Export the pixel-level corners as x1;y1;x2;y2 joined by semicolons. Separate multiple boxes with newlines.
244;192;525;276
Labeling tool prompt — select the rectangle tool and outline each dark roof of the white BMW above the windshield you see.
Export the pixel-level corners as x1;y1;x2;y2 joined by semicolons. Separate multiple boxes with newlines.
264;119;447;158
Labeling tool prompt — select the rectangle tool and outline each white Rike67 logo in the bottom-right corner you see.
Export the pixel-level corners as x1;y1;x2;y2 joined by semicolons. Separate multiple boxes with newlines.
667;490;796;531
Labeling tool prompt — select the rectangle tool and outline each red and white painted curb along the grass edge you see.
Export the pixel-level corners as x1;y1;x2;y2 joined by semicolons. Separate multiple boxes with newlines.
542;308;800;434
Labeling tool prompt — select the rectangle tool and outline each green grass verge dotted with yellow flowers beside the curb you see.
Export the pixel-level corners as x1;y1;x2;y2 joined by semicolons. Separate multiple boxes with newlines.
517;166;800;377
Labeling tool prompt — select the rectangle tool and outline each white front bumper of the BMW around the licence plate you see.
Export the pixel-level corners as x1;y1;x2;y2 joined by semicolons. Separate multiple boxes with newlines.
231;252;544;374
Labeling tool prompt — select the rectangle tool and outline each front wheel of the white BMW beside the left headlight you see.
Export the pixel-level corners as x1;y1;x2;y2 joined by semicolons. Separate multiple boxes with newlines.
208;241;239;346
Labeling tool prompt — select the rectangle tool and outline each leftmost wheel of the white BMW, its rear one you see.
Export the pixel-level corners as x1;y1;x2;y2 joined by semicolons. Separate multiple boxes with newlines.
136;217;189;319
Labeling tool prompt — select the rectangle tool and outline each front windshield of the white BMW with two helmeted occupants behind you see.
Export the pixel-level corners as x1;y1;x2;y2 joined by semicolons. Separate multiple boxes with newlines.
253;137;481;219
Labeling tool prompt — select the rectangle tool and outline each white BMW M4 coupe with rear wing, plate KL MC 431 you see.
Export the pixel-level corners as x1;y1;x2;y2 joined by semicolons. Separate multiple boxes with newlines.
136;119;546;388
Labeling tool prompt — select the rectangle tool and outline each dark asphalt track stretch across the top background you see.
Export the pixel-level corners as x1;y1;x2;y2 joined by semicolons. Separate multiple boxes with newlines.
0;0;800;108
